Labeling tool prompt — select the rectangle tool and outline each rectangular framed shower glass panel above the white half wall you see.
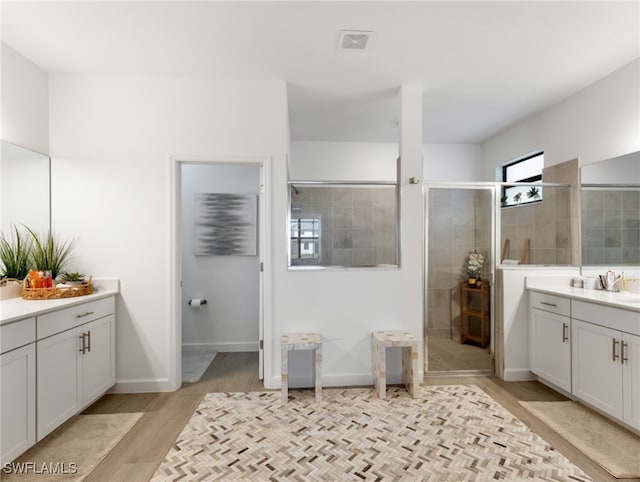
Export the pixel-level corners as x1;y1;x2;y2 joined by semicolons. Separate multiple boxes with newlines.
288;182;399;268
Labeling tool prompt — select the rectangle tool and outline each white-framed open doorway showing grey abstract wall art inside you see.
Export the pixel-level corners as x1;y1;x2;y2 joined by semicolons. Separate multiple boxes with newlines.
171;157;269;389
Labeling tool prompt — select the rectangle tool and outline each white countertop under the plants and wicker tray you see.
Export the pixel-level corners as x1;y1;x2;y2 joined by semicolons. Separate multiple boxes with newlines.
0;279;120;325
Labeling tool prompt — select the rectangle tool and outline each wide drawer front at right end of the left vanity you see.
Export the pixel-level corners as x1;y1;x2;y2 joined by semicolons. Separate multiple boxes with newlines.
38;296;116;340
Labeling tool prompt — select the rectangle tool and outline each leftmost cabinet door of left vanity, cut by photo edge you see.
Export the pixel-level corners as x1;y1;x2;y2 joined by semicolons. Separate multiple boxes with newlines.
0;343;36;464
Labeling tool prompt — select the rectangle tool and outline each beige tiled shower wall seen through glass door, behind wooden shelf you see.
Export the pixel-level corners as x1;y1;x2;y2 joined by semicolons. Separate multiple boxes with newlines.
427;188;493;340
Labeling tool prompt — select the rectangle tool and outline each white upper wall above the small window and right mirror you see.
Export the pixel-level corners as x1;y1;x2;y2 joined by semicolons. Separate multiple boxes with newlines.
482;60;640;181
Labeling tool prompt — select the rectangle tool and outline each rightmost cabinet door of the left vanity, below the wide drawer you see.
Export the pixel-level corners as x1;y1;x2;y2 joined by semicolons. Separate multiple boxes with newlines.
80;315;116;406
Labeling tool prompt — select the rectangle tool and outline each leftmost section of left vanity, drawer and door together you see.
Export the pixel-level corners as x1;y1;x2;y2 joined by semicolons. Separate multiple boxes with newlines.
0;318;36;464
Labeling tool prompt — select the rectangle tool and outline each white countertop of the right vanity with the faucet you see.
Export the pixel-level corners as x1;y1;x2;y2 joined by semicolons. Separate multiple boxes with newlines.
525;277;640;312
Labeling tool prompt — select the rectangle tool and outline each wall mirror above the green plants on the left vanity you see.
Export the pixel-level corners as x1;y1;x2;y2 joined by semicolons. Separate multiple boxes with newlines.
0;141;51;236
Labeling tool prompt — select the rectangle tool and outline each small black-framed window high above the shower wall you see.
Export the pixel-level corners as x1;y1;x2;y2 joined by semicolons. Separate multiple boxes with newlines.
501;152;544;207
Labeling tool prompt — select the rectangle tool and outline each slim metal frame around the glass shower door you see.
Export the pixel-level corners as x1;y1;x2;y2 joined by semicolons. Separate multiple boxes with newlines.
422;182;502;376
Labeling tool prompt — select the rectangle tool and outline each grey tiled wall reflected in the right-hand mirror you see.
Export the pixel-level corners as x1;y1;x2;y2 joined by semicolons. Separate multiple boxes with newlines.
581;188;640;265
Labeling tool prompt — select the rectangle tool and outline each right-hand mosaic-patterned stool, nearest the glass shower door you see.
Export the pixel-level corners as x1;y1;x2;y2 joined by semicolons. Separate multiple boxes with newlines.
371;331;420;399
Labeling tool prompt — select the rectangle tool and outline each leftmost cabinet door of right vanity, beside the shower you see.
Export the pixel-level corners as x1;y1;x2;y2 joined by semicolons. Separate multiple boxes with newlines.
531;309;571;392
